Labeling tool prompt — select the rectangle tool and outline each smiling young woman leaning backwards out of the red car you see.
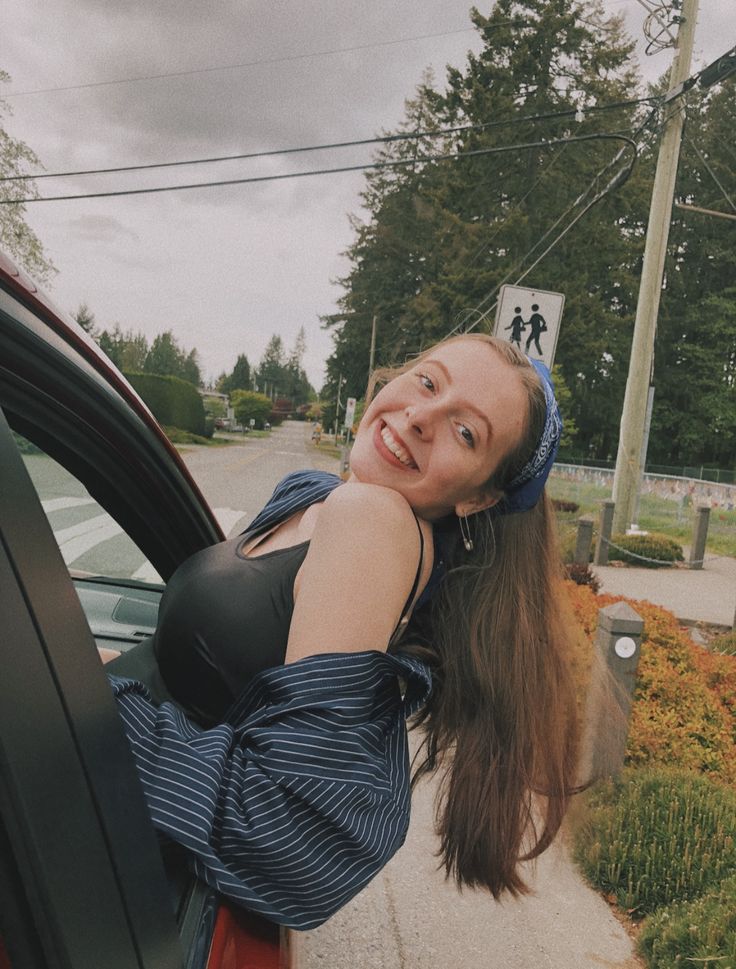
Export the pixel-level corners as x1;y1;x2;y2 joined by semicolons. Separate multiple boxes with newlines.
108;335;577;928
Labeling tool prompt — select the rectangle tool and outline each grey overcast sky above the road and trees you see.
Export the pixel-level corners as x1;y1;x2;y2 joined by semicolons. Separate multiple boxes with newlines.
0;0;736;389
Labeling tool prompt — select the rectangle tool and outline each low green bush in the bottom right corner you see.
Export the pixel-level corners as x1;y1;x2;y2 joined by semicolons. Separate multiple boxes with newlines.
638;875;736;969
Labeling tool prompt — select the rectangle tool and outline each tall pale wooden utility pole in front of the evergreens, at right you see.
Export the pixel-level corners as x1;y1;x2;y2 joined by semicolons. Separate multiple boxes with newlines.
613;0;698;532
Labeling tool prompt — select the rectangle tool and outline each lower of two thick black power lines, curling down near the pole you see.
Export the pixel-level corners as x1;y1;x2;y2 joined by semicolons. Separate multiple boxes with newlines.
0;132;637;205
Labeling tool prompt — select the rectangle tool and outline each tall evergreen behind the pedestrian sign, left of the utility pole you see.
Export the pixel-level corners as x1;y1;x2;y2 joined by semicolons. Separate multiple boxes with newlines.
325;0;642;448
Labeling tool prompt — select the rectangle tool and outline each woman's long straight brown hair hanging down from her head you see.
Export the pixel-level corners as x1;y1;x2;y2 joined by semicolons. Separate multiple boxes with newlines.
369;334;579;898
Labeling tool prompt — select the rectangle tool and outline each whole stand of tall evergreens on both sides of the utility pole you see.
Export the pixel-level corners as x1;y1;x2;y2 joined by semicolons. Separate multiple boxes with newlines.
323;0;736;467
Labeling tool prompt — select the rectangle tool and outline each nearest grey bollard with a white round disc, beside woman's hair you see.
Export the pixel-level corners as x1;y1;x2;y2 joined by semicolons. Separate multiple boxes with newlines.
583;602;644;780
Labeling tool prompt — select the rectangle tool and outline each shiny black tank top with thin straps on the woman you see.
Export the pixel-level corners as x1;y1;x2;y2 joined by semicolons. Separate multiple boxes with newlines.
154;522;424;725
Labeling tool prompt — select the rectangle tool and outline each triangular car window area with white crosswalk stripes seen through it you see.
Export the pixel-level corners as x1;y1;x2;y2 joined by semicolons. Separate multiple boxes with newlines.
15;434;161;583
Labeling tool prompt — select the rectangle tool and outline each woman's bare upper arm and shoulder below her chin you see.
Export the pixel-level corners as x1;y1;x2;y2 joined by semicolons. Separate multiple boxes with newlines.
286;482;432;663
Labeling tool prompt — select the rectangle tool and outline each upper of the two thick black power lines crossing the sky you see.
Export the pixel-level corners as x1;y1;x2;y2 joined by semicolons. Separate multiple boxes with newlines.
0;97;656;182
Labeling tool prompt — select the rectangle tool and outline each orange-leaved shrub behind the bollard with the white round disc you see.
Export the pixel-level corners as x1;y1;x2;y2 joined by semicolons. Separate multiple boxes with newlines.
566;583;736;784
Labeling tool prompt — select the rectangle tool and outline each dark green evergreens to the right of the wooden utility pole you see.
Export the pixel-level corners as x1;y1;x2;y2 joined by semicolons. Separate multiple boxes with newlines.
648;82;736;468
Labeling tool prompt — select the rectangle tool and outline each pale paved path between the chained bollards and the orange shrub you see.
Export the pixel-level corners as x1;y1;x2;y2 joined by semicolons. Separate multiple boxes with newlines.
591;554;736;629
